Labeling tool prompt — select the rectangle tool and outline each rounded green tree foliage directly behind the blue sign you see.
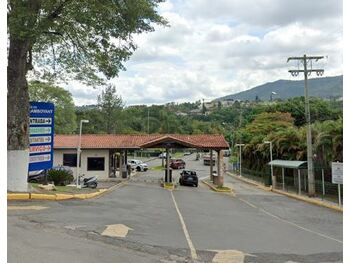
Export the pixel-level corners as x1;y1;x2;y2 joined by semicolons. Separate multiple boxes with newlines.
28;81;77;134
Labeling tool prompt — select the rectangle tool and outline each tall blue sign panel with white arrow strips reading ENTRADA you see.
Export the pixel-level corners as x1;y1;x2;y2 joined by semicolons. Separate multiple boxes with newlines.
29;102;55;171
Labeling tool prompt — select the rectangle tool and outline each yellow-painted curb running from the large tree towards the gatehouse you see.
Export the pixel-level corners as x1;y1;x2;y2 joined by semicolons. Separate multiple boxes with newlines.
7;182;125;201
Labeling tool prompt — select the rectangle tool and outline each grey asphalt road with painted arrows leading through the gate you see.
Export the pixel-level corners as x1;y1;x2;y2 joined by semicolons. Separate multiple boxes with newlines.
8;156;343;263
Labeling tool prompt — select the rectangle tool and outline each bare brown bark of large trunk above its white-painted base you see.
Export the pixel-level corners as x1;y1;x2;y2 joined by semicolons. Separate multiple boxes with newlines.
7;38;30;150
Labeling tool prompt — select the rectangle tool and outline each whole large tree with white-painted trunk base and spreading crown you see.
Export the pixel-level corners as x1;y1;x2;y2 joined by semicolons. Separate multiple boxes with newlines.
7;0;166;190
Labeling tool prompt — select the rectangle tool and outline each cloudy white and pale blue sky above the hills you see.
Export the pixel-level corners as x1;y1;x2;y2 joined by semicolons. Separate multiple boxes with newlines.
66;0;343;105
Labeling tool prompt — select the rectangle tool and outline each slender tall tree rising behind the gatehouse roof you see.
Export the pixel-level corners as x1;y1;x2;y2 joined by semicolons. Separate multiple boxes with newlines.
97;85;123;134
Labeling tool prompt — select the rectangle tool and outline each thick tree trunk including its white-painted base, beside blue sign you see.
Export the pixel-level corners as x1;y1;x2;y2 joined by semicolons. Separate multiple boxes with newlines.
7;37;30;192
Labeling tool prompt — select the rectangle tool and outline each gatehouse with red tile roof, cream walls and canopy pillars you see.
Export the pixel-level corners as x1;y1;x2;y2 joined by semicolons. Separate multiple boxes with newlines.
54;134;229;186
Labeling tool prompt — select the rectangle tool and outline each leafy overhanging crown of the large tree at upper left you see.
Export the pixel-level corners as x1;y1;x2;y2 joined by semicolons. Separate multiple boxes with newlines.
8;0;167;83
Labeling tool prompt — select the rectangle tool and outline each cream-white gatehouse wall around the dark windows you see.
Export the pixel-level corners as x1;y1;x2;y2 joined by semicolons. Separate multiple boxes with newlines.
53;149;109;180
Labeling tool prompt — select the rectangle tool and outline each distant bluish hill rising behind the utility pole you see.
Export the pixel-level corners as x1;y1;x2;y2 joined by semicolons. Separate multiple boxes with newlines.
216;75;343;101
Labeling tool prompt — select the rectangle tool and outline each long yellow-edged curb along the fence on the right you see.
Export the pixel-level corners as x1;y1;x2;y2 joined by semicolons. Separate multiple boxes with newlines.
226;172;343;212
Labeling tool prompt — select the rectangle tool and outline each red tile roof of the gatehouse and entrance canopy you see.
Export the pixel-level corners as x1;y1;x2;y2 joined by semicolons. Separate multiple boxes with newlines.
54;134;229;149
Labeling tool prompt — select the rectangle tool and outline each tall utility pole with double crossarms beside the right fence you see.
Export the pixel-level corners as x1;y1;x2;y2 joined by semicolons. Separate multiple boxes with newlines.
287;55;324;196
